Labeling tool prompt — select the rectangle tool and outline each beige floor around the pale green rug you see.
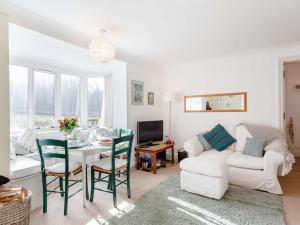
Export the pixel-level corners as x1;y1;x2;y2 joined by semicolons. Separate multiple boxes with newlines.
30;158;300;225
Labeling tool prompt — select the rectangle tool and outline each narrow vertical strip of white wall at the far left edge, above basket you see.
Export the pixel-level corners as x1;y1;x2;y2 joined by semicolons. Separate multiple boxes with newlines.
0;13;9;176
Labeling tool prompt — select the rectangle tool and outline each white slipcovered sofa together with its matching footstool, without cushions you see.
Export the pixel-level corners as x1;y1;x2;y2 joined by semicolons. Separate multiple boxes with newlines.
180;125;283;199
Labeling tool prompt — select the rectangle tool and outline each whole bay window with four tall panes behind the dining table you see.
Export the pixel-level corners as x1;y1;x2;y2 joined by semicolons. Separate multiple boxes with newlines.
9;65;105;133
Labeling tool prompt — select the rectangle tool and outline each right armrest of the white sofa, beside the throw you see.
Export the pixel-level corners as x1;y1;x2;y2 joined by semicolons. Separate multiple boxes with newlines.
264;151;283;177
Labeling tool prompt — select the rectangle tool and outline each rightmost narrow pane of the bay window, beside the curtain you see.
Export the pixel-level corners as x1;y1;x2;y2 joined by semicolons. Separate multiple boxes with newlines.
88;77;104;124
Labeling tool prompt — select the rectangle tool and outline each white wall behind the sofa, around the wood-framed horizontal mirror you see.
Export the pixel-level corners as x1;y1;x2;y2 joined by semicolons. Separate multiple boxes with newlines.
162;45;300;148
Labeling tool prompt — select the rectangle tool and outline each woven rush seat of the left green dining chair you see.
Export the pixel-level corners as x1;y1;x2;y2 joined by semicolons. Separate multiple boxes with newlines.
45;162;82;176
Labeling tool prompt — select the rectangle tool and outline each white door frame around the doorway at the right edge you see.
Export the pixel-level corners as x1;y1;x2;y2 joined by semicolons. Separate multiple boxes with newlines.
278;55;300;137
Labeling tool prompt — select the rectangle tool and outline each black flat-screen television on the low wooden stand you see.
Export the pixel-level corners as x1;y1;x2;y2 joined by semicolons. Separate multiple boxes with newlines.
137;120;164;145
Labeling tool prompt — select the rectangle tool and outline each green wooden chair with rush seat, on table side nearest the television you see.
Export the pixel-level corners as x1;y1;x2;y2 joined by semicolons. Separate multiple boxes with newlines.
90;134;133;207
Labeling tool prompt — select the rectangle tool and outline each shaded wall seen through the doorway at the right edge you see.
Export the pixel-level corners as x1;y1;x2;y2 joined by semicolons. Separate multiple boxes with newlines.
284;62;300;156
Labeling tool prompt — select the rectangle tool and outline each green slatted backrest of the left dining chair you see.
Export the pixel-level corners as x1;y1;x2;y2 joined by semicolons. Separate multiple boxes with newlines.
36;139;69;173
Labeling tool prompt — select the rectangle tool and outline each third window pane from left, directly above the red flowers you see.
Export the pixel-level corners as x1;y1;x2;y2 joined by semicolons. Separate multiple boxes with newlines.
61;74;80;117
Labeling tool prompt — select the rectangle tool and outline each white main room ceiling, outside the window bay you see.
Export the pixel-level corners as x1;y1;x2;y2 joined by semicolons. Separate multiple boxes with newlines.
4;0;300;65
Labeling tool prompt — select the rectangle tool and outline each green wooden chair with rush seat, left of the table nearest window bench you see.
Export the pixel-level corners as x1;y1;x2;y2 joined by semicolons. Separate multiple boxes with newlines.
36;139;89;215
